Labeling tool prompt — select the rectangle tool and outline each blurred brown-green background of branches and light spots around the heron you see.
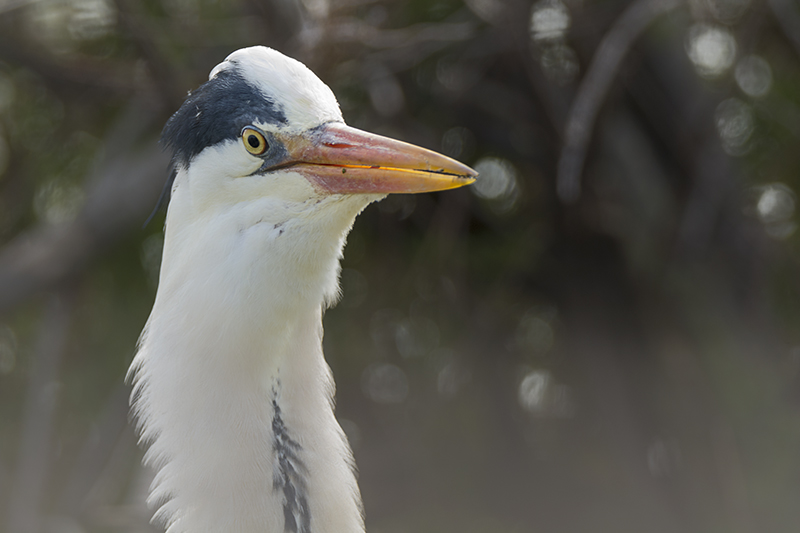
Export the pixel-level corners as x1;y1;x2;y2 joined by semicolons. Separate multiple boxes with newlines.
0;0;800;533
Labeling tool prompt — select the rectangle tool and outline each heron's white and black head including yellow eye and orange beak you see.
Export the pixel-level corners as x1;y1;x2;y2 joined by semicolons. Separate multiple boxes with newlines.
163;46;476;227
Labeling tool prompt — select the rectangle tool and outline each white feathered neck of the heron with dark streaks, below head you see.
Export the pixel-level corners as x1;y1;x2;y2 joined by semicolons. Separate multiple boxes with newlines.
132;195;363;533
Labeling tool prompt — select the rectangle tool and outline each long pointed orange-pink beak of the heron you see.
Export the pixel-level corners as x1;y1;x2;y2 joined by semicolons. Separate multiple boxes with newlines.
283;122;478;194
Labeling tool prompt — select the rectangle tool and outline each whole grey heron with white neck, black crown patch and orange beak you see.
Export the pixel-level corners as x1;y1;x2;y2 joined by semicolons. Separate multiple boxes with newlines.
129;47;477;533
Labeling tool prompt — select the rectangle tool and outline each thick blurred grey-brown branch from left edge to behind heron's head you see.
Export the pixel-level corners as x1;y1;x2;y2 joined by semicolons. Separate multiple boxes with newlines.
0;102;168;314
